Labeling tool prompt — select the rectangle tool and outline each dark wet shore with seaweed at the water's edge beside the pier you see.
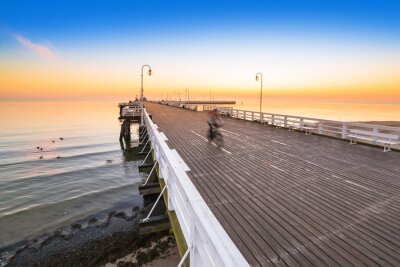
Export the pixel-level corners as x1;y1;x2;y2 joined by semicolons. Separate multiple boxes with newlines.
0;198;179;267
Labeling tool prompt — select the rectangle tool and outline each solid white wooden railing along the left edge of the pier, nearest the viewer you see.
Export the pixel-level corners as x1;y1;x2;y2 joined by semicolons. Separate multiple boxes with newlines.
144;109;249;267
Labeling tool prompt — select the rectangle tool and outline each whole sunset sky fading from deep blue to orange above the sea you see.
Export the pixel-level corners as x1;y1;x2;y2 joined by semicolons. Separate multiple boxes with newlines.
0;0;400;103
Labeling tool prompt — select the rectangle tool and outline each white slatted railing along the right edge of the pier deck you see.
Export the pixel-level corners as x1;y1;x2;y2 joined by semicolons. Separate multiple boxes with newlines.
203;106;400;148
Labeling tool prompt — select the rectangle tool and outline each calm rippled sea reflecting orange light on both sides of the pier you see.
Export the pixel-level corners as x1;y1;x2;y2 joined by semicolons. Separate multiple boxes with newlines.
0;100;400;247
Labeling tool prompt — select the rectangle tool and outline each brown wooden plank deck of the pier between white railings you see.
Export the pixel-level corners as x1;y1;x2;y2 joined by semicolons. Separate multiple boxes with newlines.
145;103;400;266
